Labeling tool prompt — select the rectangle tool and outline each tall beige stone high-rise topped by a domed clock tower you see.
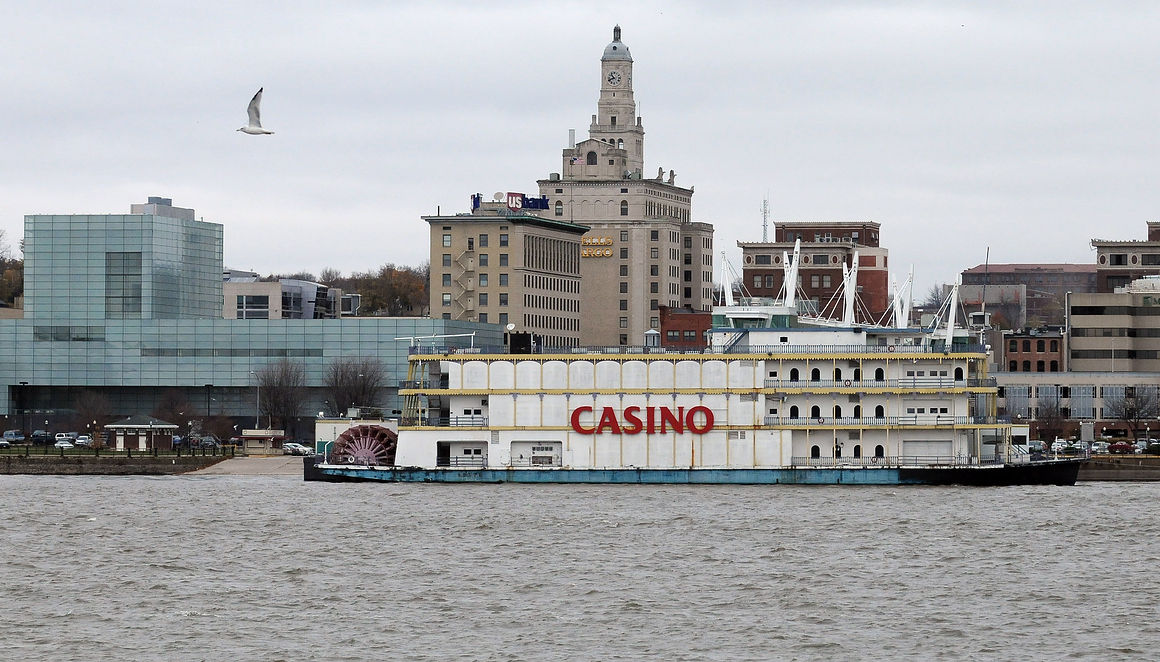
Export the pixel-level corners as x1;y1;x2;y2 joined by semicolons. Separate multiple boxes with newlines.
535;27;713;345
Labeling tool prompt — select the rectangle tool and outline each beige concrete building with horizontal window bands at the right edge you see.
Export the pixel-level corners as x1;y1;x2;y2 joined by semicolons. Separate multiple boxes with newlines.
1068;277;1160;372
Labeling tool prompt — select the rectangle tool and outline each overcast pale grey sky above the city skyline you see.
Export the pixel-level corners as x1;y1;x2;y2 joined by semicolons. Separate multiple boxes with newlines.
0;0;1160;289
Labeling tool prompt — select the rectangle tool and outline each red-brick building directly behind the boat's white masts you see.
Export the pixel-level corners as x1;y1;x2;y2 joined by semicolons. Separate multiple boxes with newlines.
737;220;891;322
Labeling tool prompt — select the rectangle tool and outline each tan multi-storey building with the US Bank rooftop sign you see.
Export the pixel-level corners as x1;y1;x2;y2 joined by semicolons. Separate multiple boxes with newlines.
423;199;588;348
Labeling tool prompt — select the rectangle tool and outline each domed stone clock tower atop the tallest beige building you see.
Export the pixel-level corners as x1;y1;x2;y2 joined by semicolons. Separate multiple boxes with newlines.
588;26;645;173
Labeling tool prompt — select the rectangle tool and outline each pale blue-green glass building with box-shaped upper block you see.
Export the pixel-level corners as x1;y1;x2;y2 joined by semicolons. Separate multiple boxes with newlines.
0;198;503;431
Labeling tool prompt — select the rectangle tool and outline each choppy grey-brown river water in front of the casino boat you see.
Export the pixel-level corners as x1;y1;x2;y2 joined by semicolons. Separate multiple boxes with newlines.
0;475;1160;661
